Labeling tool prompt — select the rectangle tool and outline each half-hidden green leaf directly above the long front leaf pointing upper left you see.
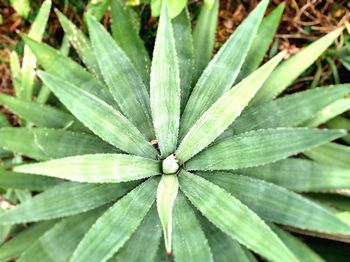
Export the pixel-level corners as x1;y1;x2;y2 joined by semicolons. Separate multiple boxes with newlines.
22;36;118;109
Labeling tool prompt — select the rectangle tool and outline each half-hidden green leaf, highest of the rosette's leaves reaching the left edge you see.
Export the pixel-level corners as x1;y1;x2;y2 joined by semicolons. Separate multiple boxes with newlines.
0;94;88;131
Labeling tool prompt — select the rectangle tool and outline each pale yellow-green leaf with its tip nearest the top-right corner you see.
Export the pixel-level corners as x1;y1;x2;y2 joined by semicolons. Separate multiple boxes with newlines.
251;28;343;105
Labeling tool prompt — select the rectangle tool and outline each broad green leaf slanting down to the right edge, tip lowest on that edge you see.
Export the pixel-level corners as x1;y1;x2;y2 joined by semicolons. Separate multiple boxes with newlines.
199;172;350;234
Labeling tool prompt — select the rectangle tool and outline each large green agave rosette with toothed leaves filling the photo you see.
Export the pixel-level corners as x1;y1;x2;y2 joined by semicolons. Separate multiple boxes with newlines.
0;0;350;261
